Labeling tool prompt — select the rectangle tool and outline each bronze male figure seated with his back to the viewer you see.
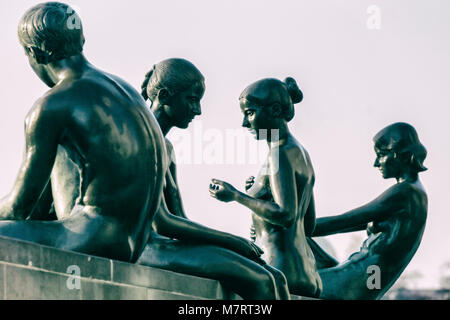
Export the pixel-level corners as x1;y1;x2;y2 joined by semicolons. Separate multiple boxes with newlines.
0;2;167;262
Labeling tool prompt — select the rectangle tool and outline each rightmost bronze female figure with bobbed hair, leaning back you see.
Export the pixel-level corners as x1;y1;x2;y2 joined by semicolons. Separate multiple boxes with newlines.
314;123;428;299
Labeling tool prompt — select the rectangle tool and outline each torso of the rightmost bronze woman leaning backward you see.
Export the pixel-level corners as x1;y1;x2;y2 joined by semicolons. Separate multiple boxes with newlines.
320;181;427;299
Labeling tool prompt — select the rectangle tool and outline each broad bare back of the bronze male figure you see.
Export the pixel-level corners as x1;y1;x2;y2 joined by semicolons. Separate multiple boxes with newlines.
49;70;166;258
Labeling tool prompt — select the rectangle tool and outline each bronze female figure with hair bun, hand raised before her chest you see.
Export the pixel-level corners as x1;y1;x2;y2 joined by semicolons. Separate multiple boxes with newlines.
209;78;321;297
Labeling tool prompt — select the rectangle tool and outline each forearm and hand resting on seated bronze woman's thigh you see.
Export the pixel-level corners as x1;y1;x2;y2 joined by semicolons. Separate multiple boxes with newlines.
153;198;263;259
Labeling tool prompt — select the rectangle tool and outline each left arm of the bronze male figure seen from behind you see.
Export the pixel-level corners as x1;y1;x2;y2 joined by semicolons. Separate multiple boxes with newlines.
0;99;63;220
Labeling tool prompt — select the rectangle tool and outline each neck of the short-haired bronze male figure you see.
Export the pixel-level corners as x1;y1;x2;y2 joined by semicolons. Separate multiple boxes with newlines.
48;53;90;84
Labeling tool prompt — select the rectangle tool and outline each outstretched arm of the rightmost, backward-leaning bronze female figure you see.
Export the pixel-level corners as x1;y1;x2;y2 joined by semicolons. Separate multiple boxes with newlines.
313;185;407;237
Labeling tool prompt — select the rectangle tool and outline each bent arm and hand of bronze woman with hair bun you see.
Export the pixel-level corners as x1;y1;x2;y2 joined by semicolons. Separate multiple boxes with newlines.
210;150;298;228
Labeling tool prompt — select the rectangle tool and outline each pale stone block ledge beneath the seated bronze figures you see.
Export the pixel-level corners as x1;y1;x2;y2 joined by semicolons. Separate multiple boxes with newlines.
0;237;240;300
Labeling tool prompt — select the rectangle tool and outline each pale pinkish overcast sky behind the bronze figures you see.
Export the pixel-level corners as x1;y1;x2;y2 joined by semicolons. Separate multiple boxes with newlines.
0;0;450;287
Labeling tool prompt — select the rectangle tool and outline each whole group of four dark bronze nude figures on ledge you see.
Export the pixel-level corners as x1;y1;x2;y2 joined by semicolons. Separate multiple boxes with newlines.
0;2;427;299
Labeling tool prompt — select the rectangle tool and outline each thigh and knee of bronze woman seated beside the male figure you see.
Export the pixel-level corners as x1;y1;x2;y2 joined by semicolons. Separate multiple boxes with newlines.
138;239;279;300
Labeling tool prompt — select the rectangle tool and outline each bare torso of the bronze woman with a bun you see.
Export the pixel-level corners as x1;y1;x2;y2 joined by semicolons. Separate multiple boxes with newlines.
248;139;321;295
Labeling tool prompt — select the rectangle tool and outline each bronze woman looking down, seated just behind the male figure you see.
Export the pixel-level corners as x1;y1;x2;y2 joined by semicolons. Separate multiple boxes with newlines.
138;59;289;299
